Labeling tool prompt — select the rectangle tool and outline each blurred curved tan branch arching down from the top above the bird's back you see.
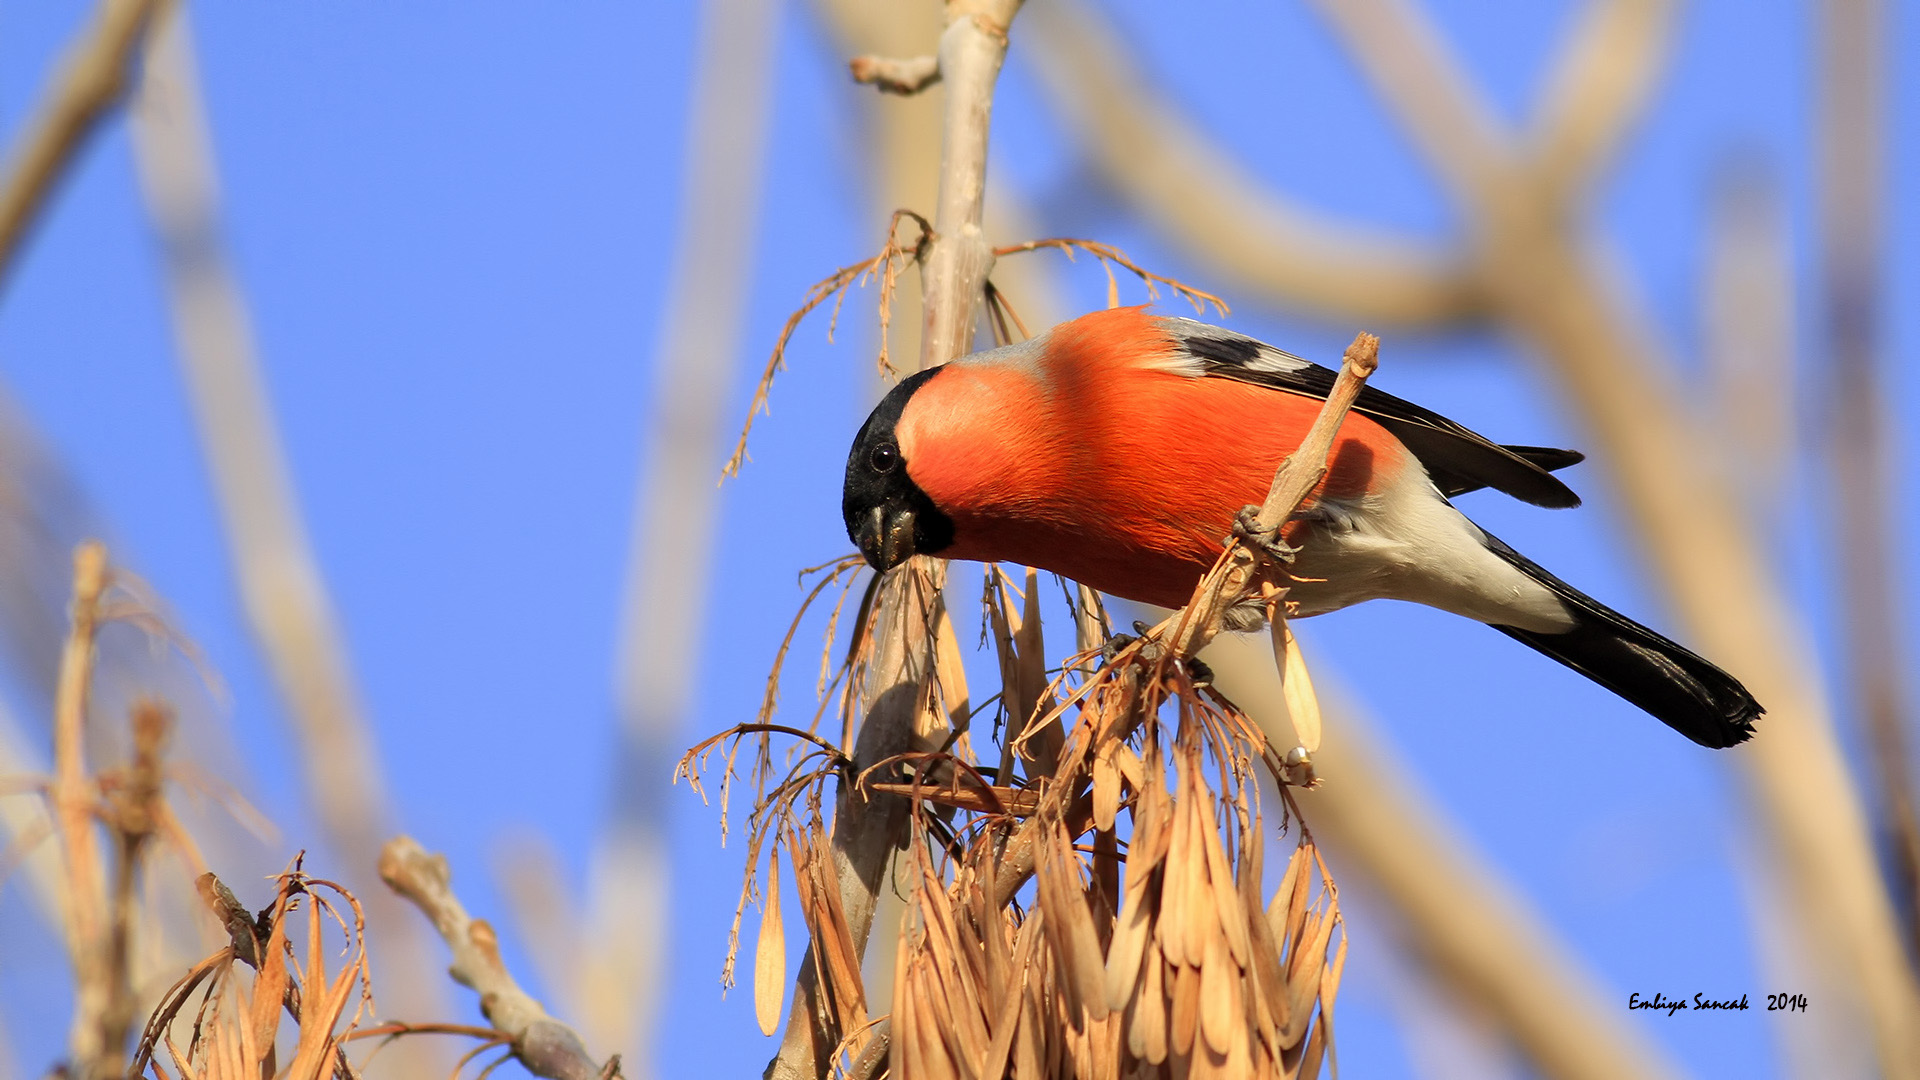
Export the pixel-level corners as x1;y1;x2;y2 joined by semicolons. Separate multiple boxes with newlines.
1029;0;1480;325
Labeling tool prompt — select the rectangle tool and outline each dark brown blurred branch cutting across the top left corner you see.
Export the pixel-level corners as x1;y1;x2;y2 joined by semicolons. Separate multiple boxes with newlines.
0;0;159;288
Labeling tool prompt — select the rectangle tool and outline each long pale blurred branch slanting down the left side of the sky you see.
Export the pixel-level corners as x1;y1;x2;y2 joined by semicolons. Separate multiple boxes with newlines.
132;8;444;1037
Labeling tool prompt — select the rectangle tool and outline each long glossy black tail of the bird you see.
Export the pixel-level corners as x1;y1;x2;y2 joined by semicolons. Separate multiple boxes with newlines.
1486;536;1764;749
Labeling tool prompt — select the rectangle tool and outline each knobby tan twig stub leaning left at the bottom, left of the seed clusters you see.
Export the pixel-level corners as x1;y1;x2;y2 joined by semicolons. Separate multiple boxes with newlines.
380;836;620;1080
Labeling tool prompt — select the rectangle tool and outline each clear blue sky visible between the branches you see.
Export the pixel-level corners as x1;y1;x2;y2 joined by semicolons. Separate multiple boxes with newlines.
0;0;1920;1076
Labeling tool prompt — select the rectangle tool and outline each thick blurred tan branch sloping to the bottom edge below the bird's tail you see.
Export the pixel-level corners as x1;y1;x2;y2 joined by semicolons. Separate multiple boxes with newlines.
1202;636;1682;1080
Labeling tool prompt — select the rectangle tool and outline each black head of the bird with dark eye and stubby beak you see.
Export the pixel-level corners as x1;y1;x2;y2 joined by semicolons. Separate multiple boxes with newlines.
841;367;954;573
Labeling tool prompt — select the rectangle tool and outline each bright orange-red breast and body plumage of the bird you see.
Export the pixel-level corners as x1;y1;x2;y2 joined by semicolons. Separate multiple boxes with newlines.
900;352;1407;607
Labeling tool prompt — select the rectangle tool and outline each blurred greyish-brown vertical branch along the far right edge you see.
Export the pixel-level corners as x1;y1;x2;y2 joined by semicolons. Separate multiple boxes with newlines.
1818;0;1920;957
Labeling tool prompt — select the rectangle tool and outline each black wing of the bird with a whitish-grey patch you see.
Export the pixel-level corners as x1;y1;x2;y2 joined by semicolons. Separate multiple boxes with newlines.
1162;319;1584;509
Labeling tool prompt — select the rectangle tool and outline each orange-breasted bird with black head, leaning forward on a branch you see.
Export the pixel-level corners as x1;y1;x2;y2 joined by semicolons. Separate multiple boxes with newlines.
841;306;1763;748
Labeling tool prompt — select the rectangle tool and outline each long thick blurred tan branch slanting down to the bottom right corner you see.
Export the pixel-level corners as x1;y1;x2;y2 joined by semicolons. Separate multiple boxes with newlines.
1321;0;1920;1076
